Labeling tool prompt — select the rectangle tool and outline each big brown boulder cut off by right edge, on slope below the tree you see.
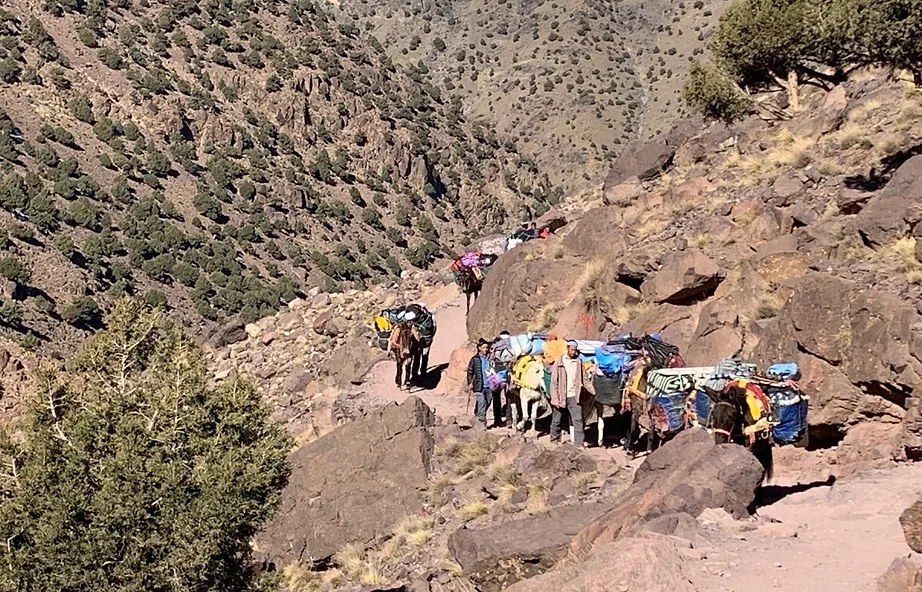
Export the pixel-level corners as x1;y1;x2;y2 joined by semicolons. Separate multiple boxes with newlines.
856;155;922;245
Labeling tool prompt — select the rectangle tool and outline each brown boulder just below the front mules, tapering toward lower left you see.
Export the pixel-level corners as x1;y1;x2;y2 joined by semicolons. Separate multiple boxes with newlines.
570;430;763;560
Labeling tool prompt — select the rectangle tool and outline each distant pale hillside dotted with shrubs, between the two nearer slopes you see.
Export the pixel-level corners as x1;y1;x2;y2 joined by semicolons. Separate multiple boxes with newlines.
336;0;727;189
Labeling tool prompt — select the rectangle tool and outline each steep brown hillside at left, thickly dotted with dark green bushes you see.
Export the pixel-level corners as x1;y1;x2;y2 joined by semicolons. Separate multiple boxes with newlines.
0;0;559;354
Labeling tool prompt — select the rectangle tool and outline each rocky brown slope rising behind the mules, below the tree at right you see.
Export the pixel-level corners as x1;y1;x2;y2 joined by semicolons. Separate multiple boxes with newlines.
468;75;922;462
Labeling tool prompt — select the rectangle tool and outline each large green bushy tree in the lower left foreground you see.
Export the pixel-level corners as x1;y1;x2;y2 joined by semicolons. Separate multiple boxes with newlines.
0;300;290;592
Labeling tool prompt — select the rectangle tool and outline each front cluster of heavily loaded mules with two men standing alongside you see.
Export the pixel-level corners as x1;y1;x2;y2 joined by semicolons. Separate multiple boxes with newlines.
467;331;809;458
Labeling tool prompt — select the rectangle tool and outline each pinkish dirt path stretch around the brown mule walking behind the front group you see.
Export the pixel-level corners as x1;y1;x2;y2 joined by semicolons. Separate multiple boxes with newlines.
350;285;467;418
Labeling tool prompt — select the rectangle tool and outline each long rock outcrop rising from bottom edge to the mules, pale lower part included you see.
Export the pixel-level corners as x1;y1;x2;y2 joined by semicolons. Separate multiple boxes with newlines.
500;430;762;592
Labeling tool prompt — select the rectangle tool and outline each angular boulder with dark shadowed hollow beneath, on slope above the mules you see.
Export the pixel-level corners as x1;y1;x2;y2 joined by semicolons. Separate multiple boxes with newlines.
640;250;724;304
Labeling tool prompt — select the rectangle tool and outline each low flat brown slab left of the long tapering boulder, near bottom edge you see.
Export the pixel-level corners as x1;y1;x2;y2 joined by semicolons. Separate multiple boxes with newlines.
448;503;611;589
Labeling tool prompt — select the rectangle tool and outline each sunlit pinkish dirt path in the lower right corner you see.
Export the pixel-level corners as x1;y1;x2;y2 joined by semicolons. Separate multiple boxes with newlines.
688;464;922;592
